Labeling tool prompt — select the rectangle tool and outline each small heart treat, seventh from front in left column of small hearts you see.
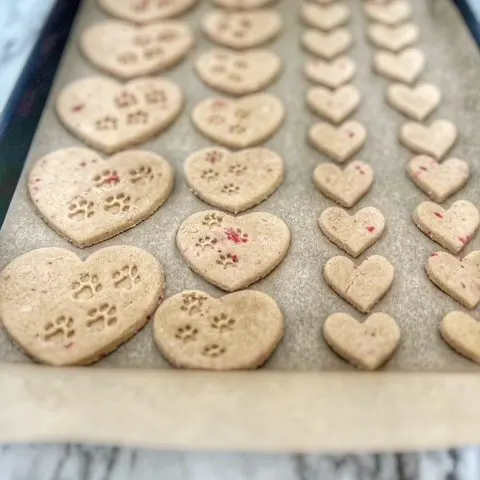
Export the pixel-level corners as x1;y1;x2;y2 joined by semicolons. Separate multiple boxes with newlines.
305;57;357;88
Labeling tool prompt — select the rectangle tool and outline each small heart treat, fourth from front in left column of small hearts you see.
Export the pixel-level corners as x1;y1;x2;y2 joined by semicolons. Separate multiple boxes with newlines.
313;160;374;208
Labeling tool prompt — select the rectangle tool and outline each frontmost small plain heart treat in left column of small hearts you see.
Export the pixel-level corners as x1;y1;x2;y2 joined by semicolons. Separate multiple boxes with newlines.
323;313;401;370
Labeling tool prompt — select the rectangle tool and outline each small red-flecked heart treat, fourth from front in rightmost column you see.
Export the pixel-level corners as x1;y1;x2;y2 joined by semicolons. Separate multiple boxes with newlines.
407;155;470;203
